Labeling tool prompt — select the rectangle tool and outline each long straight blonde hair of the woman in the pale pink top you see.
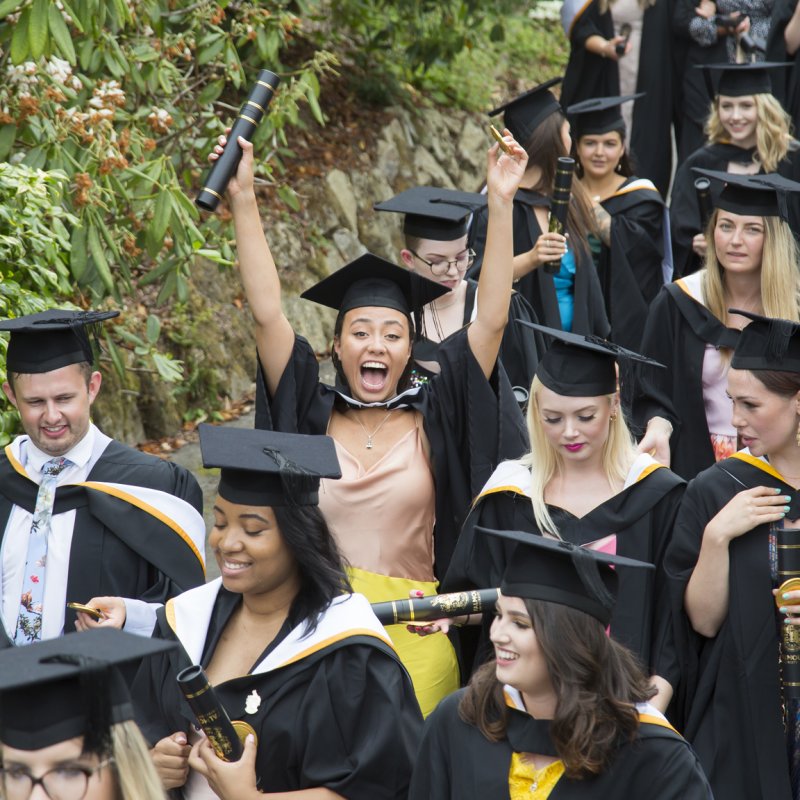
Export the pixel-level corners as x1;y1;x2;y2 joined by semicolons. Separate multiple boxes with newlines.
702;210;800;322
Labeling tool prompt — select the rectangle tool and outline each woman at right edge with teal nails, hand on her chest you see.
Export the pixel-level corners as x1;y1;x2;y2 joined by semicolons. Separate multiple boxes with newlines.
665;309;800;800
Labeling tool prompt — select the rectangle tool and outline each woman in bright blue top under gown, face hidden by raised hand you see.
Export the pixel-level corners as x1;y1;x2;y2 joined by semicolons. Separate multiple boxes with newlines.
469;78;609;336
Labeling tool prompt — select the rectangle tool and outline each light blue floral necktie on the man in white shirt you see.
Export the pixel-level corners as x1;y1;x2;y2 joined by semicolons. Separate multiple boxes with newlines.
14;456;72;645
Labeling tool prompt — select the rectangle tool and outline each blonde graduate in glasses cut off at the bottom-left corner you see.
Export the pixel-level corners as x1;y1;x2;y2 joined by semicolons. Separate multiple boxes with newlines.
0;628;173;800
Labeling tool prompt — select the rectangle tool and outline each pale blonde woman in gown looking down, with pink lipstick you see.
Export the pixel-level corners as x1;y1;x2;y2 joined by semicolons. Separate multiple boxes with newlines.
445;326;683;709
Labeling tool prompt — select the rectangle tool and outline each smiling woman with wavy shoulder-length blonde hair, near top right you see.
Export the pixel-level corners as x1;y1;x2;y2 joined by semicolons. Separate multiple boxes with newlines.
670;62;800;277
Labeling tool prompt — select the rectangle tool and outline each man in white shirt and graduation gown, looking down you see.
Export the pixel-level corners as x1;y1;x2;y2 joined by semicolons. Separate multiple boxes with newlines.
0;309;205;647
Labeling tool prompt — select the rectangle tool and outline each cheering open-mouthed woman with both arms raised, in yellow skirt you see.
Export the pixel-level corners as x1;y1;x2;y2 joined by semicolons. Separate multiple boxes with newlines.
218;128;527;713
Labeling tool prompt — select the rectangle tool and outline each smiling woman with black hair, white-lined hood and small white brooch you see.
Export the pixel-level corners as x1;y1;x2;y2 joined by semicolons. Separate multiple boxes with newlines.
134;426;421;800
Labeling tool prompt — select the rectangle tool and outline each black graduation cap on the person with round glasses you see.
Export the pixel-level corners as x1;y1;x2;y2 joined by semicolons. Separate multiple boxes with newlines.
374;186;487;242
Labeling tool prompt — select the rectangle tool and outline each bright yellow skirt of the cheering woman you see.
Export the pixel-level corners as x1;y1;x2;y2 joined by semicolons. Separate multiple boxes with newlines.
348;567;459;717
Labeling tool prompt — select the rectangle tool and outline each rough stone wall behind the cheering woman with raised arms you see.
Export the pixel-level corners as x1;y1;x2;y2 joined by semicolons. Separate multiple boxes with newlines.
94;104;484;443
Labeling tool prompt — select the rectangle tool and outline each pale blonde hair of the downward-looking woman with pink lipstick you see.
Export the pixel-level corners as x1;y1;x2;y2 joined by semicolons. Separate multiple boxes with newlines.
522;377;636;539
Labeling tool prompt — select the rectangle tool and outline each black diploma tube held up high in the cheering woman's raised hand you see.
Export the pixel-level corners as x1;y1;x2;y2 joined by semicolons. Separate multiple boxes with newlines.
195;69;280;211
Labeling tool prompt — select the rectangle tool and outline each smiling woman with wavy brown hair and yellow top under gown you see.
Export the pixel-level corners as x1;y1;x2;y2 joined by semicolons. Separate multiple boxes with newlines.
409;531;711;800
